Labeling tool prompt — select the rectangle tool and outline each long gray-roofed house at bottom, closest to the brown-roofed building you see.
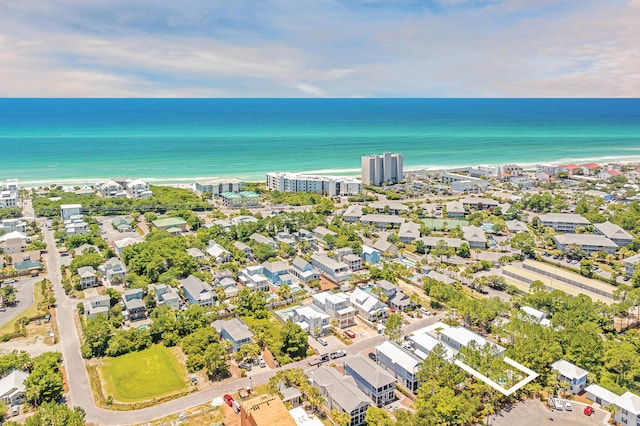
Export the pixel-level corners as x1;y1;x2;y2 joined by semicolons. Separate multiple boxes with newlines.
309;366;371;426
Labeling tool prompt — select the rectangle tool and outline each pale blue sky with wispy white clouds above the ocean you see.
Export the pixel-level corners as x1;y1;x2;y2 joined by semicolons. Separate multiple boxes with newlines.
0;0;640;98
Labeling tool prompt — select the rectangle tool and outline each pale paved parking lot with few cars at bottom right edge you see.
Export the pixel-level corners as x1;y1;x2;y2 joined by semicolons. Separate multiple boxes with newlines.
487;400;606;426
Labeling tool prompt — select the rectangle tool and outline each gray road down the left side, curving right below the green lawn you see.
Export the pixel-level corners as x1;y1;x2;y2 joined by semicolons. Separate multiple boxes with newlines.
43;223;437;425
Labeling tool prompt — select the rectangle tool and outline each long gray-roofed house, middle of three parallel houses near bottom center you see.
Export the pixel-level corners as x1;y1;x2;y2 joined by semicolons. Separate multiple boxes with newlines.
344;354;398;407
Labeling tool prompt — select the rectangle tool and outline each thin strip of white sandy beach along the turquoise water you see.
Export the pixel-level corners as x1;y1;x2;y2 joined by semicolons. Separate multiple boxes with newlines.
11;155;640;189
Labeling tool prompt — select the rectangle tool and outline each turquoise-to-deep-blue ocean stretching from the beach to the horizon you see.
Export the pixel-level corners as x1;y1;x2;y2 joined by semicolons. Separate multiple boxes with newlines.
0;99;640;186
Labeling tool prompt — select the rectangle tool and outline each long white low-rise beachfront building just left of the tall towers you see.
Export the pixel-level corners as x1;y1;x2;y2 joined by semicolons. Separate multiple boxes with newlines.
267;172;362;197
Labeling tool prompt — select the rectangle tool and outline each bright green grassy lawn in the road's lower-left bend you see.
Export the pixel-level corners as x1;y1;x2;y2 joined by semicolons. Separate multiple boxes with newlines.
100;345;187;402
